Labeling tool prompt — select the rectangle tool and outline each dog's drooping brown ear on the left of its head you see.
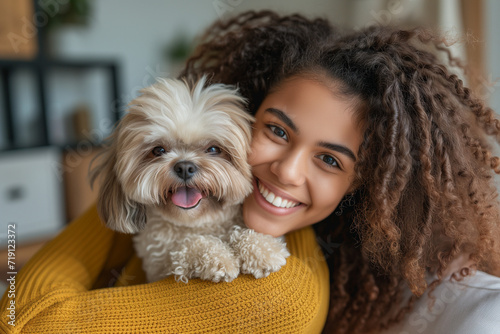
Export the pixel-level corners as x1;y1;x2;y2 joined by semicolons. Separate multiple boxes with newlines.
89;147;146;233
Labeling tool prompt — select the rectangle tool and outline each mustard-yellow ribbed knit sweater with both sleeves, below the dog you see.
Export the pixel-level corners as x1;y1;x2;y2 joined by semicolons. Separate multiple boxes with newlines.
0;207;329;334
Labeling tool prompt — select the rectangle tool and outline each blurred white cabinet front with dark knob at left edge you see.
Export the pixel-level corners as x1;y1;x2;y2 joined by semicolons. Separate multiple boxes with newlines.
0;147;65;245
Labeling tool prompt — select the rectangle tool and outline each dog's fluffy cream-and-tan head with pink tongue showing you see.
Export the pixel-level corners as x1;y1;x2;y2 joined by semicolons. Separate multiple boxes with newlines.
91;79;252;233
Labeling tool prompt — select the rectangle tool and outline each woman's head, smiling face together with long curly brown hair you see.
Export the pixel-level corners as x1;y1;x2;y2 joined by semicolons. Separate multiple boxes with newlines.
183;12;500;333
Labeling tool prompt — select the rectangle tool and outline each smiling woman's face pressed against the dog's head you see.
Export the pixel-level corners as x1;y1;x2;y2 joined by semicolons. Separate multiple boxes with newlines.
243;77;362;236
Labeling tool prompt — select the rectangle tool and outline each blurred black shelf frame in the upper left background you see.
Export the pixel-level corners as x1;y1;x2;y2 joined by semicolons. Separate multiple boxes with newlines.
0;0;121;150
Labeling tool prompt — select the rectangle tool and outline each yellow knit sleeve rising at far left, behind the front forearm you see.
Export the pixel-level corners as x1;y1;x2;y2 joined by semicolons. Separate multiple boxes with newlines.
0;208;124;332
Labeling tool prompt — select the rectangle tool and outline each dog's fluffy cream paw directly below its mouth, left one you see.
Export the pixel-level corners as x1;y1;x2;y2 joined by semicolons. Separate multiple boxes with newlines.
171;238;240;283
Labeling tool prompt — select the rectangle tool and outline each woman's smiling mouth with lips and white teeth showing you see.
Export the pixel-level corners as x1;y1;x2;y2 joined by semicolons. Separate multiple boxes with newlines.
253;178;304;216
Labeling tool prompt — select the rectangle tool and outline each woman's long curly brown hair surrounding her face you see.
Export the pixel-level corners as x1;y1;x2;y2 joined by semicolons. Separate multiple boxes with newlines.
181;11;500;333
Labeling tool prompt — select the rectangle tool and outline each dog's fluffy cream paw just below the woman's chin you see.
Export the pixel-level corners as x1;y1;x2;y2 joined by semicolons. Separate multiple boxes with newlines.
231;228;290;278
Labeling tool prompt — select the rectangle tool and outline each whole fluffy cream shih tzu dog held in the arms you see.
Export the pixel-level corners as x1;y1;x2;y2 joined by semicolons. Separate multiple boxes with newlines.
90;78;289;282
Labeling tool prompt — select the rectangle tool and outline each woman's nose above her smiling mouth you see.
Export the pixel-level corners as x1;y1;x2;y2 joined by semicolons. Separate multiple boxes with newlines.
271;150;307;186
